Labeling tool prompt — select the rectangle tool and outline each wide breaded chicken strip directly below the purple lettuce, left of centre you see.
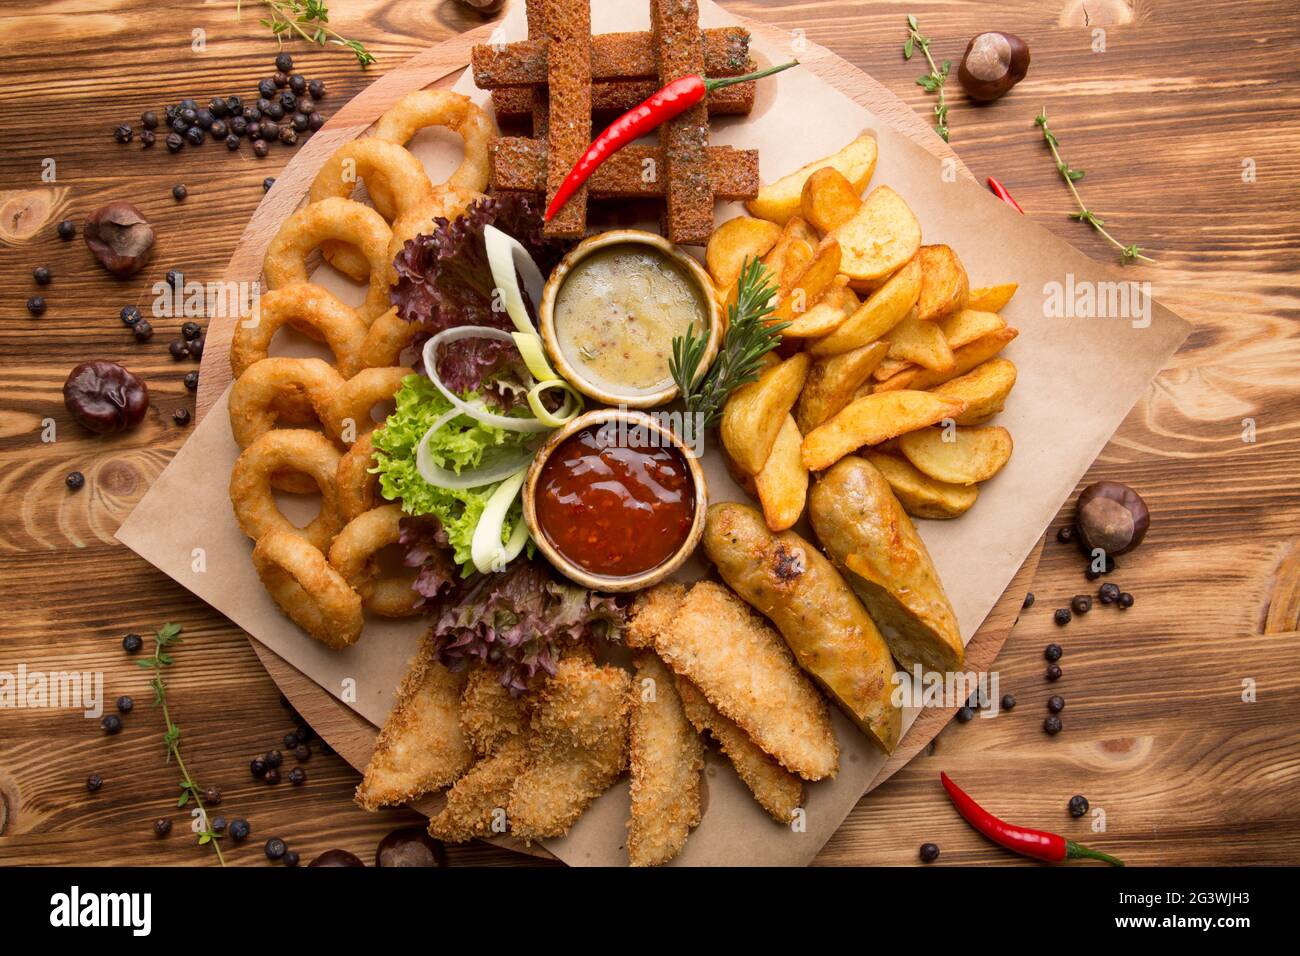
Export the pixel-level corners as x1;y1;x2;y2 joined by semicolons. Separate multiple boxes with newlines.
506;657;632;842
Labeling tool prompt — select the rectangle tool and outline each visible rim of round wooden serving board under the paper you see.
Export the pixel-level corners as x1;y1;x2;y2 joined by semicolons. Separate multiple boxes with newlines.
196;9;1043;856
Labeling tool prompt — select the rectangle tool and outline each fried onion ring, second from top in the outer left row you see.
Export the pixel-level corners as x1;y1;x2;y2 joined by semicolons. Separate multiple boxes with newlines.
308;137;433;282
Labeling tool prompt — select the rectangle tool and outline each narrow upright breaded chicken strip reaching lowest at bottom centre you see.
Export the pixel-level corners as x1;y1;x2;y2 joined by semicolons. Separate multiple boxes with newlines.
628;652;705;866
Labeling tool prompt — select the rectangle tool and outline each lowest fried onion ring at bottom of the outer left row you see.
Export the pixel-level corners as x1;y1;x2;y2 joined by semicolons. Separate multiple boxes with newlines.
252;531;365;650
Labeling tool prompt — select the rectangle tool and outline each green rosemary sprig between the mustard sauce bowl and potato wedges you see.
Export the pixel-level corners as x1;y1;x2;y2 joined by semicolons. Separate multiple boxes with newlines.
668;259;789;428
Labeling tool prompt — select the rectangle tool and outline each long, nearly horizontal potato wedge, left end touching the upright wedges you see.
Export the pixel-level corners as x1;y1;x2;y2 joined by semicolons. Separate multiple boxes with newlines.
803;389;966;471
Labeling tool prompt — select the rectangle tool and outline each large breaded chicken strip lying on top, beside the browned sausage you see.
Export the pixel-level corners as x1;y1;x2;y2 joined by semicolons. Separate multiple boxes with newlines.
644;581;840;780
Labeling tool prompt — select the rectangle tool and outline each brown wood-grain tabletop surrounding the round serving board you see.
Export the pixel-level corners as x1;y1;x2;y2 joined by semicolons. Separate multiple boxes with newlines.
0;0;1300;865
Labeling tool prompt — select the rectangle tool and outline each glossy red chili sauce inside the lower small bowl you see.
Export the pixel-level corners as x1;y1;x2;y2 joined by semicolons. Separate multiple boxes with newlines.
537;425;696;578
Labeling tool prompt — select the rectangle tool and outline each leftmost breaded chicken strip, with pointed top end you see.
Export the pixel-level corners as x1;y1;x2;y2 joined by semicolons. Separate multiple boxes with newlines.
355;636;473;810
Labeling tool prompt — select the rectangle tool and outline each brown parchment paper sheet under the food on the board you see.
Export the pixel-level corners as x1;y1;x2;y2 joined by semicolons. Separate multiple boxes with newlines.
117;0;1190;865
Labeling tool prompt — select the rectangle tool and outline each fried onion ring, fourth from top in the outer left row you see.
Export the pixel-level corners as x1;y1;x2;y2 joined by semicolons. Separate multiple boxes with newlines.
230;282;368;378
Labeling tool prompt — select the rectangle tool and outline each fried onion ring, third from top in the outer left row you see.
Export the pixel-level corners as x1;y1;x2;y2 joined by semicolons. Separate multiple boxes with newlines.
263;196;393;325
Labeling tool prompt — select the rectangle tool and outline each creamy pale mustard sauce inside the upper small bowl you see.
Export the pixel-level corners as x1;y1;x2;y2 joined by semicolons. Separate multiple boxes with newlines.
555;242;709;394
